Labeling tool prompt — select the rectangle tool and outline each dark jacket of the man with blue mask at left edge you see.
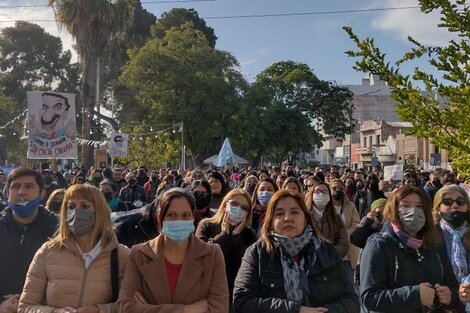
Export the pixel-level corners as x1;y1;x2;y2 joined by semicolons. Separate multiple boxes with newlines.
0;206;58;302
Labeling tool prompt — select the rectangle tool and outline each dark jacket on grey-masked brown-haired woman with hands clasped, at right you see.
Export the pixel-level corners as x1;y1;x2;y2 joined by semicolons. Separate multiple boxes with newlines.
361;223;460;313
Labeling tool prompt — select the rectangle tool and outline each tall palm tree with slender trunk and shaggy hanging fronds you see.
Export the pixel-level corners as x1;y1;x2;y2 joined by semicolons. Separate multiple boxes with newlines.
48;0;135;168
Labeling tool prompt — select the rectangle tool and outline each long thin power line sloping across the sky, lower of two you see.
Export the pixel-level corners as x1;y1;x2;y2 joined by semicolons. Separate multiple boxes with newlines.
0;5;420;23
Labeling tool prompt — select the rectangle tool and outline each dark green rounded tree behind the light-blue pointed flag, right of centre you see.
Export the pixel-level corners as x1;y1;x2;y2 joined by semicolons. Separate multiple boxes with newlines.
240;61;352;163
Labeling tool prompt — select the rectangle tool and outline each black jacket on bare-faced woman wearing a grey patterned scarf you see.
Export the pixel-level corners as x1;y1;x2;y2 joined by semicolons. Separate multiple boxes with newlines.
233;240;359;313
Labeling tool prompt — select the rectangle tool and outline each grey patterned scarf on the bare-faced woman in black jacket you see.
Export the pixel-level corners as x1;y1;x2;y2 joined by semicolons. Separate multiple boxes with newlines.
271;225;321;303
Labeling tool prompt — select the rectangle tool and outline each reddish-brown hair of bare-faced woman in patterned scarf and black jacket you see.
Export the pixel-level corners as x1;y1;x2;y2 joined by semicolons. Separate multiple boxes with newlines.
261;189;320;255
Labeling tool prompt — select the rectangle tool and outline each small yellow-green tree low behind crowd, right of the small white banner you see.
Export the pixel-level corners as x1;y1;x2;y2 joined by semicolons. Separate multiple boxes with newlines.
116;126;181;168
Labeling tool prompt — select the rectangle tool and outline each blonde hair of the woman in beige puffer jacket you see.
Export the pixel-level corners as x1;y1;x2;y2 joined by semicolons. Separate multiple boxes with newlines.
48;184;114;248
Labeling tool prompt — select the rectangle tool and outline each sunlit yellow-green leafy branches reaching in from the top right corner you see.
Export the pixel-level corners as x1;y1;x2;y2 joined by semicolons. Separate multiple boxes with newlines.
344;0;470;175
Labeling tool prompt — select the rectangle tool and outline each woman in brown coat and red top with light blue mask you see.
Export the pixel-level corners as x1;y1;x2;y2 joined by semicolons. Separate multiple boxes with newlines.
118;188;229;313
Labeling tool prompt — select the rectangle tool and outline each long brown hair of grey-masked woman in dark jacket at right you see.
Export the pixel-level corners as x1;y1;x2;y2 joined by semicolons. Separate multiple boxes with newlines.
383;185;442;248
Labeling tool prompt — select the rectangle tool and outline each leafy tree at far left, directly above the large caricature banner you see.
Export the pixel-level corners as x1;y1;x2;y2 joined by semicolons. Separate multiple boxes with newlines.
0;21;79;103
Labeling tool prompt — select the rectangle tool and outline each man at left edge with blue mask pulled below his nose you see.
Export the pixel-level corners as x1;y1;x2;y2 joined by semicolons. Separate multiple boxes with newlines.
0;168;58;313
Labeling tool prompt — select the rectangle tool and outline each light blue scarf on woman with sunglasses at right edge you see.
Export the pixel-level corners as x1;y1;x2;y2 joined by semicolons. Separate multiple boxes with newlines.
440;220;468;282
